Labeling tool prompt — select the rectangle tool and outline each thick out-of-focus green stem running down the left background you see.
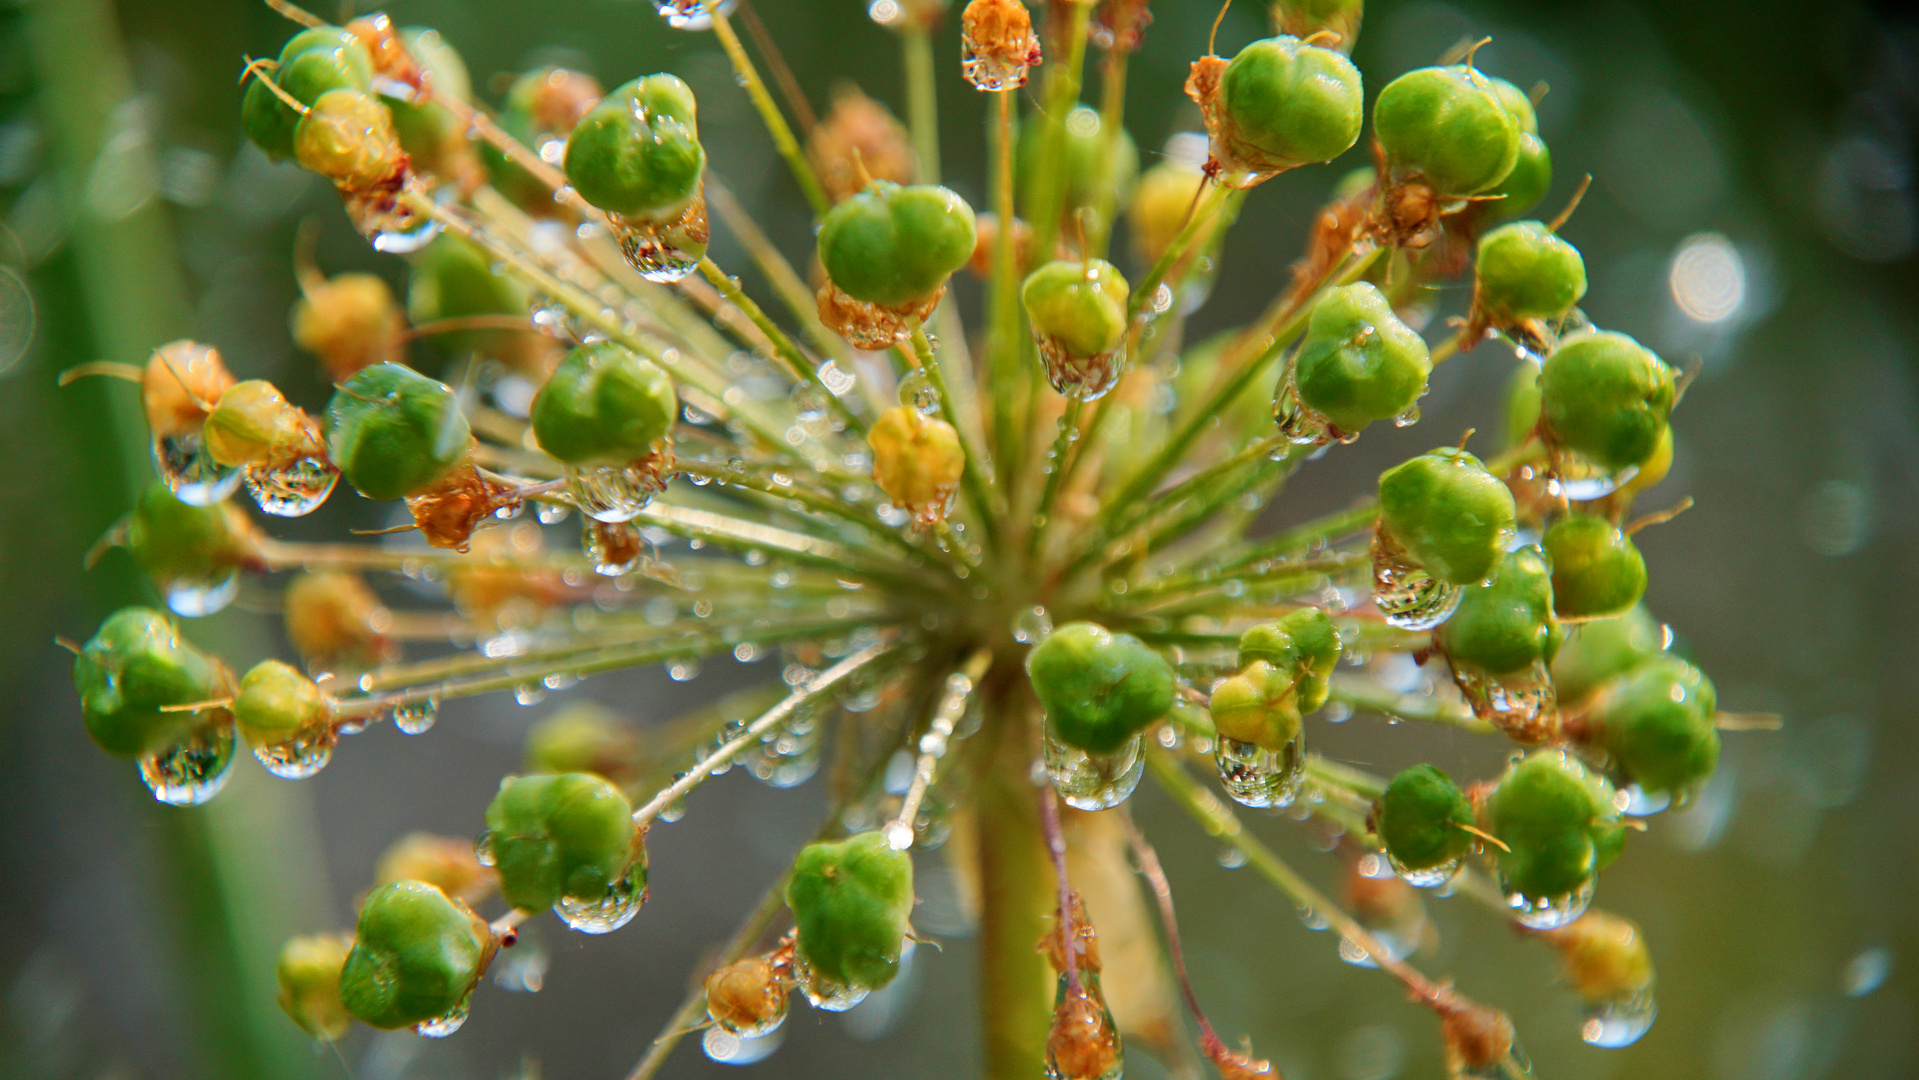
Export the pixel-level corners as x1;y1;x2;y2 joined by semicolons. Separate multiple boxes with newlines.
25;0;332;1080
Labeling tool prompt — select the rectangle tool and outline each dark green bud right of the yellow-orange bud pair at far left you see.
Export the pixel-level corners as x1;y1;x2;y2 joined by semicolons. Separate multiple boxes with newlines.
326;364;472;499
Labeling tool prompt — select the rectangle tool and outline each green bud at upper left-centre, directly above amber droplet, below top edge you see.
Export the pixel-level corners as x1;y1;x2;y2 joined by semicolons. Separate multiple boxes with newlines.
566;75;706;221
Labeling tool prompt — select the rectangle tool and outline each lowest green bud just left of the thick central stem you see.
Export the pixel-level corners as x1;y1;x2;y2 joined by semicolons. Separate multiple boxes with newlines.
787;831;913;990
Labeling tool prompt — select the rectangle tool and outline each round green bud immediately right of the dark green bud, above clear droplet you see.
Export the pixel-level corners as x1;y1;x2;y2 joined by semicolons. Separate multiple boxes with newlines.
533;341;679;464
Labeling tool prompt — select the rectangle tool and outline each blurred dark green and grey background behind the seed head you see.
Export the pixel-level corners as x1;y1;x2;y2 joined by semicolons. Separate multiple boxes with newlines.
0;0;1919;1080
